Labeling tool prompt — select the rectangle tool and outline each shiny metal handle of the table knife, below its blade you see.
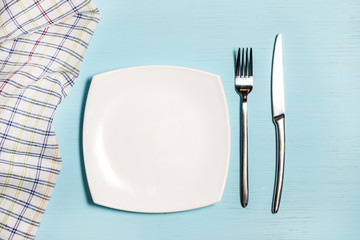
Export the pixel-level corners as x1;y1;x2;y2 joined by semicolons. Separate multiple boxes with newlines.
271;114;285;213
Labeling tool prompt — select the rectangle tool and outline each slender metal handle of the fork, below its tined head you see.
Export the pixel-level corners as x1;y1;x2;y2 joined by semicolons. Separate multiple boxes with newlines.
240;96;249;207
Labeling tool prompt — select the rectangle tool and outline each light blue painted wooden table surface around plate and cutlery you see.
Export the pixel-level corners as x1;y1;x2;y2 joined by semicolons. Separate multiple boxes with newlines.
37;0;360;240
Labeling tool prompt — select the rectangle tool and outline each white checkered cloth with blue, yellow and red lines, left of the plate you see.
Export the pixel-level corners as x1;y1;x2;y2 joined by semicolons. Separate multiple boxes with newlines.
0;0;100;239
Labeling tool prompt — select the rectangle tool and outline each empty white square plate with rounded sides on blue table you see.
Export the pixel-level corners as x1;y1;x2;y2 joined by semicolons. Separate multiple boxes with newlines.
83;66;230;213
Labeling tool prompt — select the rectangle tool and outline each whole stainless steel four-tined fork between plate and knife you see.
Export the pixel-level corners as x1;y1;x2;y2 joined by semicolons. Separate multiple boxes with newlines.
235;48;253;207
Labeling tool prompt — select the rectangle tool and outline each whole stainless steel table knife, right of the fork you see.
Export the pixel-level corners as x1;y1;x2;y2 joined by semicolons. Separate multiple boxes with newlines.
271;34;285;213
